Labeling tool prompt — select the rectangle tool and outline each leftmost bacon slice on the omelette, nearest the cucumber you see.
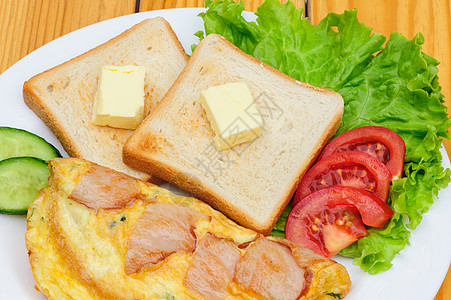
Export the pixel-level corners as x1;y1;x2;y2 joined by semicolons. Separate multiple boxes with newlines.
69;165;141;209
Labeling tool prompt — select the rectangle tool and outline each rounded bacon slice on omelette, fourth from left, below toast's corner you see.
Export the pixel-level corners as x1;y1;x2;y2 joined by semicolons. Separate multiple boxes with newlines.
234;237;305;300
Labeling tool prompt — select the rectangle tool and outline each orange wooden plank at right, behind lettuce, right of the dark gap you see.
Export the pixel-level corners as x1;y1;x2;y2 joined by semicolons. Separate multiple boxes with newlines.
308;0;451;300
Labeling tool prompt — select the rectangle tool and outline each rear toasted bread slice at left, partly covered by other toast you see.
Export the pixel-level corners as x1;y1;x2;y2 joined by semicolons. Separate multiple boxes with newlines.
23;17;188;180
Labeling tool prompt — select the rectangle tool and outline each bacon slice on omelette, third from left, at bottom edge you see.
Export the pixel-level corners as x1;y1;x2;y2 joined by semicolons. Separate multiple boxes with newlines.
184;233;241;300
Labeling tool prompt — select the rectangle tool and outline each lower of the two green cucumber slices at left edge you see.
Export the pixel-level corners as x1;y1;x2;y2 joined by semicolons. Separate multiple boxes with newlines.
0;157;50;215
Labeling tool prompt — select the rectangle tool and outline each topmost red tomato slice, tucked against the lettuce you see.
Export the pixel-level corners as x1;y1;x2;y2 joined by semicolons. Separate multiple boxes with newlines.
319;126;406;179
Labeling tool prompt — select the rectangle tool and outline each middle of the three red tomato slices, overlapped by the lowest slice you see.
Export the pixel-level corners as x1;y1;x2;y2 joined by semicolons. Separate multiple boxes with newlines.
293;151;392;206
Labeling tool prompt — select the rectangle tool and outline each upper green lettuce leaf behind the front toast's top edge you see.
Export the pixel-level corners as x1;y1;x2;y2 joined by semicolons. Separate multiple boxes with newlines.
197;0;385;90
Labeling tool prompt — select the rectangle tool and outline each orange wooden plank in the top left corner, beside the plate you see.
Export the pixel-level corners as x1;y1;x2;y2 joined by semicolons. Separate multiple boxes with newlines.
0;0;135;73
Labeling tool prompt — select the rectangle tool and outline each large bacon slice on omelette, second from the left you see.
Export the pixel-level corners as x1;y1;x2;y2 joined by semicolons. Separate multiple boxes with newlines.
125;203;209;274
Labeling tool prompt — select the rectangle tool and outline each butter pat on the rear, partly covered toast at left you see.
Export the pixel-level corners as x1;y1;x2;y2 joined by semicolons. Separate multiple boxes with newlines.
91;65;146;129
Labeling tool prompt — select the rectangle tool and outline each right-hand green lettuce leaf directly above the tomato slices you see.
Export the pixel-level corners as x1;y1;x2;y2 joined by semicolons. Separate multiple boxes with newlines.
336;33;451;145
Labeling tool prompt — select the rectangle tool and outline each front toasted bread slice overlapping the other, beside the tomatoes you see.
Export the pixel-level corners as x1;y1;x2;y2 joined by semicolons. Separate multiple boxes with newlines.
123;35;343;234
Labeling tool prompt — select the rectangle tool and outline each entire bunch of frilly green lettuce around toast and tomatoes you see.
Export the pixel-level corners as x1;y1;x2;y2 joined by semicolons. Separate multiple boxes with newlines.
196;0;451;274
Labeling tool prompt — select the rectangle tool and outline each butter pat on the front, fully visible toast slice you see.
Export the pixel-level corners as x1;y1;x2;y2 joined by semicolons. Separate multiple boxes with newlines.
200;82;263;150
